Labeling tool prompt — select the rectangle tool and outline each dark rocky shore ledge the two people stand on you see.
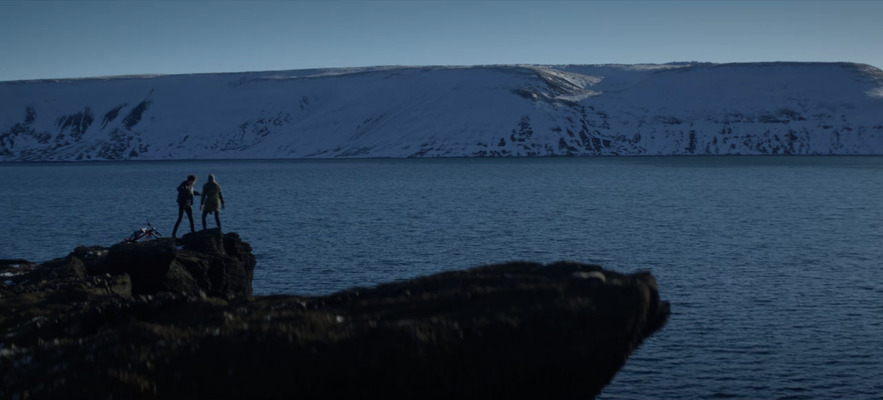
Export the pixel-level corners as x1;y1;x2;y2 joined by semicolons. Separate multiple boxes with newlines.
0;231;669;399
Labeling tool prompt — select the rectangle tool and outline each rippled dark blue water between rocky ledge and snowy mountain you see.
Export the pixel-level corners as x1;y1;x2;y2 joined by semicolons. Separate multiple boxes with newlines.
0;157;883;399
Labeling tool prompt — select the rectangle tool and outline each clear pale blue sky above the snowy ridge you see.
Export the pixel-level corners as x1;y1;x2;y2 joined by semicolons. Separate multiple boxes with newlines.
0;0;883;81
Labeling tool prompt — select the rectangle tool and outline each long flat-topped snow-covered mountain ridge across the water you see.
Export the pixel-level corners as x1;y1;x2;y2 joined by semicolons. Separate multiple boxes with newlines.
0;63;883;161
